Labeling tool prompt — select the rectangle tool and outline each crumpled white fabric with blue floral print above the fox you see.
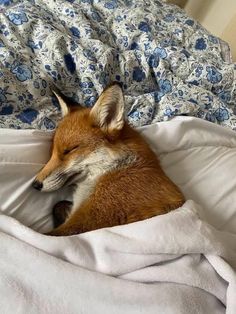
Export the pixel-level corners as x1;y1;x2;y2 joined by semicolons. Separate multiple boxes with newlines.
0;0;236;129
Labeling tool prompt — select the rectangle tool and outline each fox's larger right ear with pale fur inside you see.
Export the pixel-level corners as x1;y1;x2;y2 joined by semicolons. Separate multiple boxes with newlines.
90;83;124;135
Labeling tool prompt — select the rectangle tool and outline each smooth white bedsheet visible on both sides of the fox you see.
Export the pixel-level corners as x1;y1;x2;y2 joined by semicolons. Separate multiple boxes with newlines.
0;117;236;231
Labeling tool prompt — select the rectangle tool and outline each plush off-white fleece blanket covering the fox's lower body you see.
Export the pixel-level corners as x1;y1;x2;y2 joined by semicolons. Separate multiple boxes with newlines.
0;201;236;314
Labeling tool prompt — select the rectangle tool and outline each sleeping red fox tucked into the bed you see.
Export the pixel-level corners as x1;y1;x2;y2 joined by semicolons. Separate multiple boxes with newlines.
33;82;185;236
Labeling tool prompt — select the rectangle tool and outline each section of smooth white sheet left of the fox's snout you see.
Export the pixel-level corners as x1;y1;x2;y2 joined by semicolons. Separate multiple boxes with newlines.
0;129;68;230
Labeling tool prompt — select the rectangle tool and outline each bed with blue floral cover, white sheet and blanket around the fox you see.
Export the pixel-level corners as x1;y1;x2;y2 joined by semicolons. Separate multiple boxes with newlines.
0;0;236;314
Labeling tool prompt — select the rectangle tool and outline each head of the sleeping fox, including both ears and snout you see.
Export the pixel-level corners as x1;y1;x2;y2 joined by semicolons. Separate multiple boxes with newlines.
33;84;130;191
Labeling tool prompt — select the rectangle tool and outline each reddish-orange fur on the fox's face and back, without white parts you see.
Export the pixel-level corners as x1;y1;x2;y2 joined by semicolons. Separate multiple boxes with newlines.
34;86;184;236
